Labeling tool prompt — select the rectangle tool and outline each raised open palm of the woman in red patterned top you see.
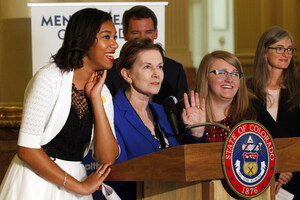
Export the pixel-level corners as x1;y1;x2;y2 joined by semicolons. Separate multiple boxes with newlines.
181;90;206;137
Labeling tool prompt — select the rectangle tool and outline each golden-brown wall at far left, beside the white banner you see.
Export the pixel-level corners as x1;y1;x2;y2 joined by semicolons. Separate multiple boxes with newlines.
0;0;31;105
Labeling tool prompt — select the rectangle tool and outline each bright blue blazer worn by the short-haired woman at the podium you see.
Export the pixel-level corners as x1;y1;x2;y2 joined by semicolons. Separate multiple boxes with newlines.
113;90;179;163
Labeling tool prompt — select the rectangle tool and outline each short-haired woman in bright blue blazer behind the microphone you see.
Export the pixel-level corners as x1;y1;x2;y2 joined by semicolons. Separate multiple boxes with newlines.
113;38;179;200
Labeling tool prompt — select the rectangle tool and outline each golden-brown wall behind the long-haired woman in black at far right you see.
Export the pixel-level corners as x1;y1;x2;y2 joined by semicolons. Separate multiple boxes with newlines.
234;0;300;77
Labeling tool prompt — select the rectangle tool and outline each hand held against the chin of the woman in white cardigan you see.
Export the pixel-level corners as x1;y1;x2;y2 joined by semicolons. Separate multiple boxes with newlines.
84;70;107;101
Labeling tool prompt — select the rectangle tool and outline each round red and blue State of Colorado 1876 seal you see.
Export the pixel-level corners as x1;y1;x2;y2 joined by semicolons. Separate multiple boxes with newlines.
222;120;276;199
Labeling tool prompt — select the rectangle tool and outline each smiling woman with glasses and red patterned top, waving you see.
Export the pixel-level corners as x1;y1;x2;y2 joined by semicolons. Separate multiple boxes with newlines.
182;51;256;142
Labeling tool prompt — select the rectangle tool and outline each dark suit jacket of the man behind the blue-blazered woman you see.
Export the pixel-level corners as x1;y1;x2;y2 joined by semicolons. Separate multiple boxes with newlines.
105;57;188;105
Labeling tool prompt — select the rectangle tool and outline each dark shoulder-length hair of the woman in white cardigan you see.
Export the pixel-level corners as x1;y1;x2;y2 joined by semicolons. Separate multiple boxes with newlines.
52;8;112;71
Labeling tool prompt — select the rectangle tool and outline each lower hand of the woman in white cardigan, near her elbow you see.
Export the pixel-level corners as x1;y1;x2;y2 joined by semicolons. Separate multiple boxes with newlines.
80;164;111;195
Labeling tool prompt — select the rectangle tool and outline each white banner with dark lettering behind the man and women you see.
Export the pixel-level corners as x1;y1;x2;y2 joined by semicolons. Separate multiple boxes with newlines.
28;2;168;74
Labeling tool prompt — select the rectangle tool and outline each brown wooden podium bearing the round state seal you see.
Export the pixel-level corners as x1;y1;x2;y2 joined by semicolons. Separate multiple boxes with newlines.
107;137;300;200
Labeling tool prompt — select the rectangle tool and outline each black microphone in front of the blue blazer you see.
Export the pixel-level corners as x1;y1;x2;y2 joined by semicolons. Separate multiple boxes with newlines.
164;96;180;141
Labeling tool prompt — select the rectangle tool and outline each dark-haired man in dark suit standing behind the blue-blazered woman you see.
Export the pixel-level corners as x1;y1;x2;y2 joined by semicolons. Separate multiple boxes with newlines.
105;6;188;105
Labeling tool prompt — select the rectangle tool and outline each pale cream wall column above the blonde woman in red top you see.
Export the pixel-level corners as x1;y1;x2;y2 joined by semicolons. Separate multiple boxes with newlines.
189;0;234;67
